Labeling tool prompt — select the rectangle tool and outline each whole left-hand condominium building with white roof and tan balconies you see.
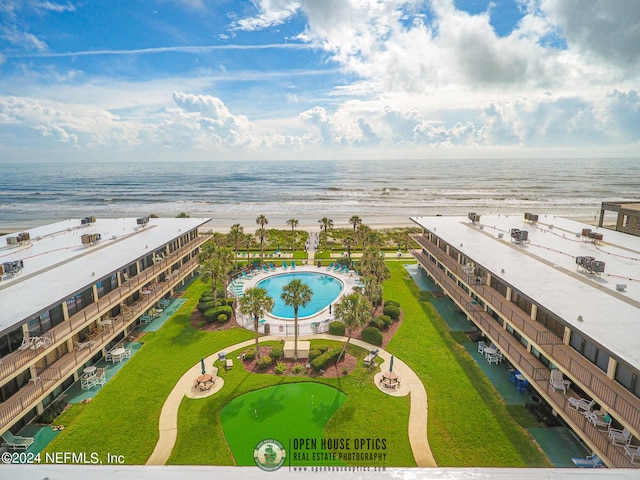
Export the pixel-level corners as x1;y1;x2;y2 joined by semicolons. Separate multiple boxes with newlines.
0;217;210;434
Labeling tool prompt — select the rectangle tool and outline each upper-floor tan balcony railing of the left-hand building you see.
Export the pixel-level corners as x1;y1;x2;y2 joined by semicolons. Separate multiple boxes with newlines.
0;236;208;383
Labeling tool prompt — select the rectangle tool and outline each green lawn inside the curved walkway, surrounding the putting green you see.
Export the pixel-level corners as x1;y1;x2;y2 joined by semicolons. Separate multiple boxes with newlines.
168;340;415;466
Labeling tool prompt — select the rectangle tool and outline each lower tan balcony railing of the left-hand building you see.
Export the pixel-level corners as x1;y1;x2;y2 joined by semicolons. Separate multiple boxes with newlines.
0;249;198;432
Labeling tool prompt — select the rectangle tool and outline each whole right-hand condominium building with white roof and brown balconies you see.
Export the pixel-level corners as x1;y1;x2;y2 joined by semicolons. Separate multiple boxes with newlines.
412;213;640;467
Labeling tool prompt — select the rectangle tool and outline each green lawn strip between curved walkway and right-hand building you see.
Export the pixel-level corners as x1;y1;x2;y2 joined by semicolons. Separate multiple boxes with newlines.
384;262;552;467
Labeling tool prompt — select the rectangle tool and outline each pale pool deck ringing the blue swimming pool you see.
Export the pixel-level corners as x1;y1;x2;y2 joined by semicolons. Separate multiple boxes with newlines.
230;265;360;337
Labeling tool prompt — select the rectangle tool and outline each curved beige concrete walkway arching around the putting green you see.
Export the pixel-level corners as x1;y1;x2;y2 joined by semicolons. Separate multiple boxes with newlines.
146;334;438;467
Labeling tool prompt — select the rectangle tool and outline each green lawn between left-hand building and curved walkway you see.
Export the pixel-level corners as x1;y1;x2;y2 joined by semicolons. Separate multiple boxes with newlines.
45;280;253;464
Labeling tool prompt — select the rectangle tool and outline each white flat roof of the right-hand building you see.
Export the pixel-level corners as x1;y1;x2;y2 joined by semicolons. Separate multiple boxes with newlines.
412;214;640;369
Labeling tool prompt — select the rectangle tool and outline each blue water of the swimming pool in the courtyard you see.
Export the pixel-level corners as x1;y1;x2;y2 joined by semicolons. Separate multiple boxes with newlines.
257;272;343;319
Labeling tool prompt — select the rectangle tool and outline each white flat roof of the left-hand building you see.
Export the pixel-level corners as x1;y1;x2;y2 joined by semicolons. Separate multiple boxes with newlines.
0;218;210;332
